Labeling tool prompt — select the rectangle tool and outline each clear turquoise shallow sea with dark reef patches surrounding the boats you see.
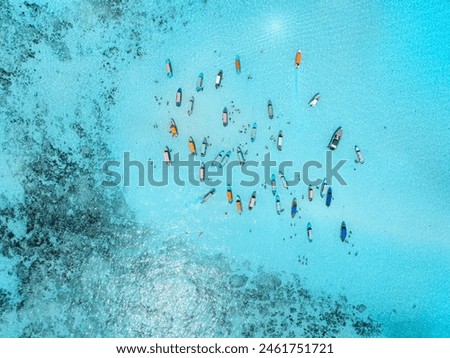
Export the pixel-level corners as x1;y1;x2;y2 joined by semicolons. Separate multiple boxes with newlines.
0;1;450;337
